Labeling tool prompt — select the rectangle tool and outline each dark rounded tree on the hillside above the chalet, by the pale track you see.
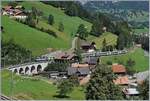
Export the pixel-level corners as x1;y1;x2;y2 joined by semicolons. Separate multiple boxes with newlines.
77;24;88;39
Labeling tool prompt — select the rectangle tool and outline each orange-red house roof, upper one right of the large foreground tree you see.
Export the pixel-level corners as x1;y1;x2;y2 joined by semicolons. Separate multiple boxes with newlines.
112;64;126;73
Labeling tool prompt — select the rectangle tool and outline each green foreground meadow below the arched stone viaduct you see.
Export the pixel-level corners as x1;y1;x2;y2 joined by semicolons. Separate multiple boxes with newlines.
1;70;84;100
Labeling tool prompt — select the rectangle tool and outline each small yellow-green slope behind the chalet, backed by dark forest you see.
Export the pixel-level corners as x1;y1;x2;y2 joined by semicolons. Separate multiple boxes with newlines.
88;32;117;48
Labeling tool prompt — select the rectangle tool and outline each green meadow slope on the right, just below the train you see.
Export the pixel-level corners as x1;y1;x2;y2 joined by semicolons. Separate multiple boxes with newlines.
100;48;149;72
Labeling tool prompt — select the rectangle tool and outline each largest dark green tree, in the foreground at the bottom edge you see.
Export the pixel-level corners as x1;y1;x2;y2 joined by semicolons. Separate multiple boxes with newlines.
86;65;123;100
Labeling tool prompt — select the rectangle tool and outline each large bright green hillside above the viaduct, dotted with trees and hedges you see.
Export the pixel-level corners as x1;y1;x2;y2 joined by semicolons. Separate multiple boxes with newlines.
2;1;91;55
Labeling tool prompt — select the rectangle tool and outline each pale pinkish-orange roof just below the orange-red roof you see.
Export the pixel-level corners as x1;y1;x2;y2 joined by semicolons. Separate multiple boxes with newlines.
113;76;129;85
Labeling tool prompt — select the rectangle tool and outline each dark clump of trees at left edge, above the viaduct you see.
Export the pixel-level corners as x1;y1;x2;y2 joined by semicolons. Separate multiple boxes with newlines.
1;40;32;66
